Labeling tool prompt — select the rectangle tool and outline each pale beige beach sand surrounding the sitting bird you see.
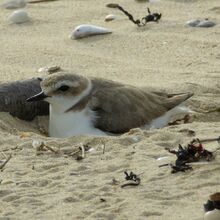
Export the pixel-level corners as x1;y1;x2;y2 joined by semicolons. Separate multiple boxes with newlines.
0;0;220;220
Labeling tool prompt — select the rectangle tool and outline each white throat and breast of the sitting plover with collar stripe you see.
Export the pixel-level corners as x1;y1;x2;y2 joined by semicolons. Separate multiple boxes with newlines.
47;81;105;138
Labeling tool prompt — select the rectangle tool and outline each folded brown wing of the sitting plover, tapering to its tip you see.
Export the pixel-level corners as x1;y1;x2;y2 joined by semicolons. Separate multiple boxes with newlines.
90;86;192;133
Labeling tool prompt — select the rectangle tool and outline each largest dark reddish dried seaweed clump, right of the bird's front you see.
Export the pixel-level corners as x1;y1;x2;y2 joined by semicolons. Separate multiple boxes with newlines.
159;137;220;173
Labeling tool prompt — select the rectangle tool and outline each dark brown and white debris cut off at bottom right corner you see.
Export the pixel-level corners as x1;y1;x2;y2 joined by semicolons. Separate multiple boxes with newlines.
204;192;220;220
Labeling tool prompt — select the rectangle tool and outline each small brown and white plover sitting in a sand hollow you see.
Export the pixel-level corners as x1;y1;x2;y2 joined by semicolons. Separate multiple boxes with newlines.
27;72;192;137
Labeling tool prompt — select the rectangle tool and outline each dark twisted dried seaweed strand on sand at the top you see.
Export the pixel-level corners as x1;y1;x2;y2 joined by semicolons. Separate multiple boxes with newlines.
106;3;162;27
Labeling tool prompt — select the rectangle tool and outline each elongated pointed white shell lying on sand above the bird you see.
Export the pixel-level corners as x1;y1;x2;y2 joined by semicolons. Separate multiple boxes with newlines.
70;24;112;39
